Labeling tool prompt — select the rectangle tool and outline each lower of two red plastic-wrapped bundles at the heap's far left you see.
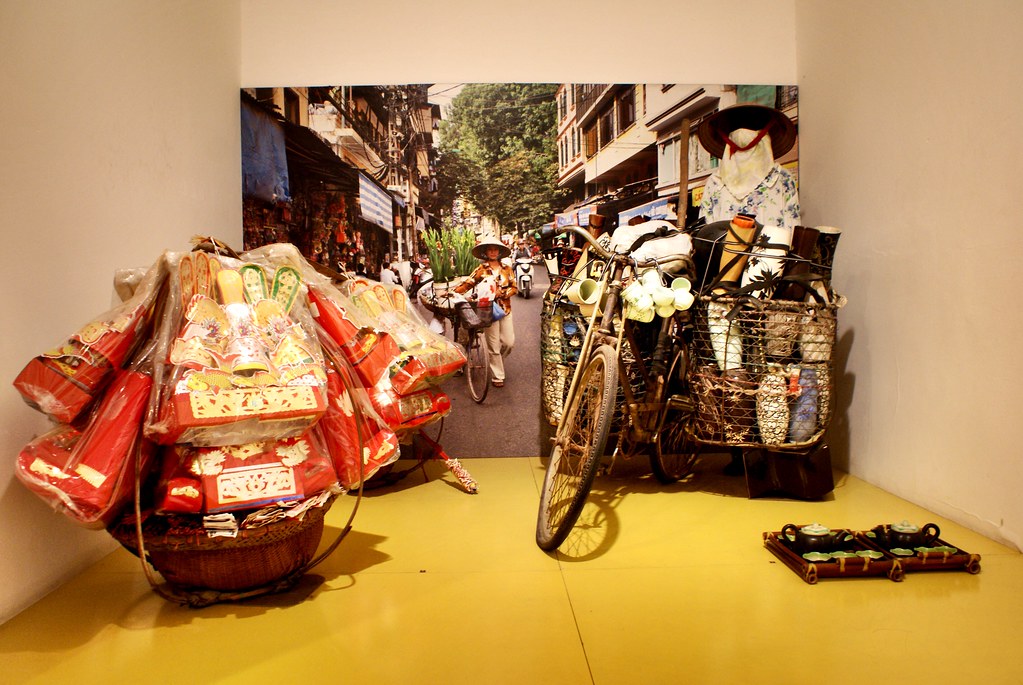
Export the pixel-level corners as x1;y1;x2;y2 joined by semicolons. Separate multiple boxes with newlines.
14;351;154;528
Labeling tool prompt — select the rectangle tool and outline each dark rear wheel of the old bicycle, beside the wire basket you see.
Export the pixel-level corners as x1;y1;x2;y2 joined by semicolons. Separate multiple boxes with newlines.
650;349;700;485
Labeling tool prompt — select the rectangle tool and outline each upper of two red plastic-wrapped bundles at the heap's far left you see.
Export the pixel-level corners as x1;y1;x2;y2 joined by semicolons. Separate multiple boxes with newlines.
14;255;168;423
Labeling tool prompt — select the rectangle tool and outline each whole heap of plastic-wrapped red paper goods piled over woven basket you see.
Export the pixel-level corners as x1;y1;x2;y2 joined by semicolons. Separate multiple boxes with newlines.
9;240;464;556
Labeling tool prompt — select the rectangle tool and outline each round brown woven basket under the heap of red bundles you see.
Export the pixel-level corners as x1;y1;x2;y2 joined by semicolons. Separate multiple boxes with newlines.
110;500;332;592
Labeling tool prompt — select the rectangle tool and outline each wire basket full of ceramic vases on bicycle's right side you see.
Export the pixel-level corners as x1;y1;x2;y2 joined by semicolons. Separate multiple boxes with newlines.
687;219;844;451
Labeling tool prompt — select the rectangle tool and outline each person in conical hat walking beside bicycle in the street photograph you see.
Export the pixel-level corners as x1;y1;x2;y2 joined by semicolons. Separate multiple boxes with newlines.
454;236;519;387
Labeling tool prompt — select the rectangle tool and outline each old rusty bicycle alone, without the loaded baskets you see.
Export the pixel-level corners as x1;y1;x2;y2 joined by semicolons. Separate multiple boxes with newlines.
536;226;699;551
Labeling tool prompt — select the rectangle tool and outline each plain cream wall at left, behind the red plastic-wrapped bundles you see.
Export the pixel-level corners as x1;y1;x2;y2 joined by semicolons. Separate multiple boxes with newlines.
0;0;241;622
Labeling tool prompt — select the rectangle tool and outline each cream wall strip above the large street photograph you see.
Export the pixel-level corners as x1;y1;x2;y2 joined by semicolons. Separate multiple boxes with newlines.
241;0;796;87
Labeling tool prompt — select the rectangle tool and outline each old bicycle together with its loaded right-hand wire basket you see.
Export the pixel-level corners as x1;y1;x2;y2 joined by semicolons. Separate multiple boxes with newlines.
536;222;845;551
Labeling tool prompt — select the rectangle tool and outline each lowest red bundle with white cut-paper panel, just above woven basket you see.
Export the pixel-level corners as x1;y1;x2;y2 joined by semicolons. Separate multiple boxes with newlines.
155;424;338;514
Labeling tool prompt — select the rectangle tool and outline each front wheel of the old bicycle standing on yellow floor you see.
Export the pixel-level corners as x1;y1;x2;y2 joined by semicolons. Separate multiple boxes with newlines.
536;345;618;551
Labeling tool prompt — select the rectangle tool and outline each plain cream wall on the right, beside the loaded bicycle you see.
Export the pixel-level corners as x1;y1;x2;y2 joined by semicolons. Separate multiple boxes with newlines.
796;0;1023;547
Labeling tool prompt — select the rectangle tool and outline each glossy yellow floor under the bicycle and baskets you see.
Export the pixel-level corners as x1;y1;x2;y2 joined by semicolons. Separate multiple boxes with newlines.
0;458;1023;685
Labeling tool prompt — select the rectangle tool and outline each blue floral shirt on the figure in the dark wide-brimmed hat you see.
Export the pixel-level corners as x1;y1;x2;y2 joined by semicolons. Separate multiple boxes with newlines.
700;165;799;228
